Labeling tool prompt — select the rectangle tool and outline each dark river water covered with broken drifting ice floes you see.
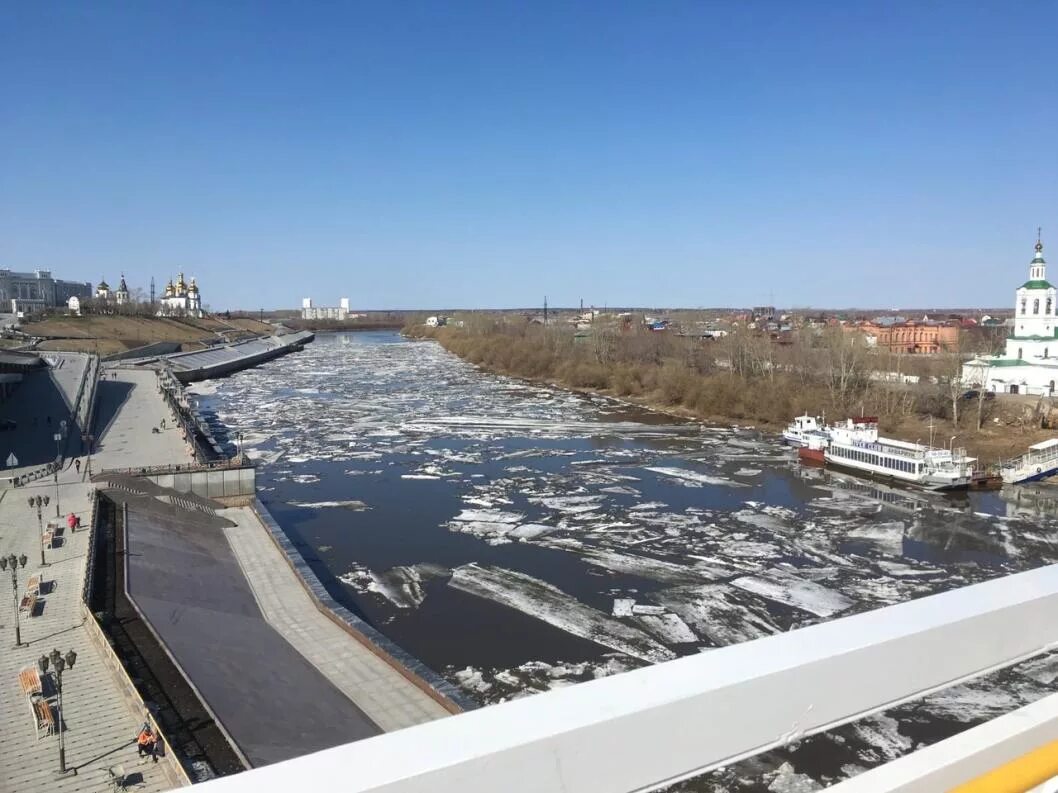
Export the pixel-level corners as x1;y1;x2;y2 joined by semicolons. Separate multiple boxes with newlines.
188;332;1058;790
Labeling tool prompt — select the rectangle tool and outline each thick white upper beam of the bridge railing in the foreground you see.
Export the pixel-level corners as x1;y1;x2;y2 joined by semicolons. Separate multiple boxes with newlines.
194;566;1058;793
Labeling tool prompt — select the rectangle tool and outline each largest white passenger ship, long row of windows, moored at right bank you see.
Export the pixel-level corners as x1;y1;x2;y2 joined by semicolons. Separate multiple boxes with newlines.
823;417;973;491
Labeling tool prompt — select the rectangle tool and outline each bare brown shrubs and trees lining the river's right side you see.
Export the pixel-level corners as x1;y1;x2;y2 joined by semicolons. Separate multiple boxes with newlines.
404;317;1058;462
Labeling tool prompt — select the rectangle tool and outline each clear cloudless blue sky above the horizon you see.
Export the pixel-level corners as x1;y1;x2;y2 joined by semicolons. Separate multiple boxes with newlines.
0;0;1058;310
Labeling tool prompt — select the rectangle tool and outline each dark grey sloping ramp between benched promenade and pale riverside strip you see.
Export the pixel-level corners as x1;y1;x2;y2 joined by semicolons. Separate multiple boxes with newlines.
120;495;381;766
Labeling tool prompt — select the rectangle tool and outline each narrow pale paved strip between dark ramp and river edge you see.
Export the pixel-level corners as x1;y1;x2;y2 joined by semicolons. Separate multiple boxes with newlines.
223;506;450;732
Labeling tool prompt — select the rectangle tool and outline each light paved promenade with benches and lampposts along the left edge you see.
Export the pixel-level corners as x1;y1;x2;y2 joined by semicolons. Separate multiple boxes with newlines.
0;365;190;793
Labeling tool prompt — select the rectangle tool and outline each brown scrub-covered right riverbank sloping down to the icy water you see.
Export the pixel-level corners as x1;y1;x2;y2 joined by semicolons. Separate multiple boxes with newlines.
403;326;1055;465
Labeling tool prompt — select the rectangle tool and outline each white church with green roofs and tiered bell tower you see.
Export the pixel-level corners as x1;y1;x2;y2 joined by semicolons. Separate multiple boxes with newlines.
963;239;1058;394
